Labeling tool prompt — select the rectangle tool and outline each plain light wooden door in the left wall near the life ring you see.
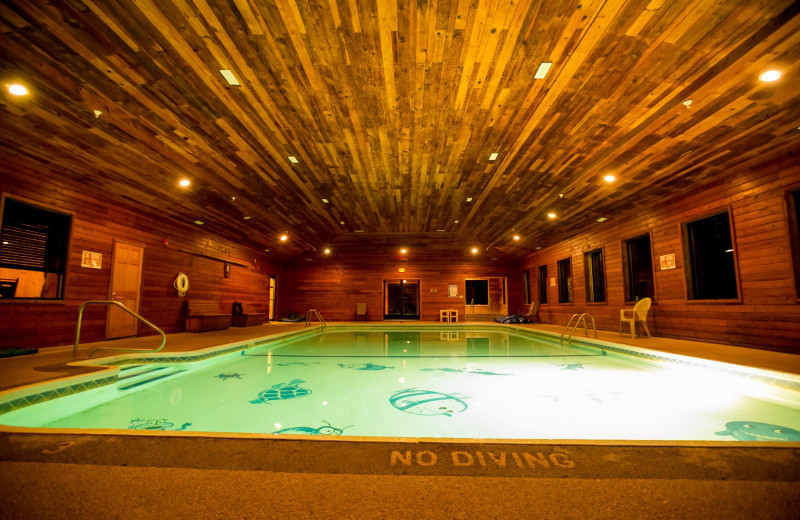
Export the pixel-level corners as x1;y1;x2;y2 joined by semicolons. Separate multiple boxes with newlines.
106;241;144;339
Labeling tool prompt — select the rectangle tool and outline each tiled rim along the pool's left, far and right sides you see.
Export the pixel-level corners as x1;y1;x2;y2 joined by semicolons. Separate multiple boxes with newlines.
0;322;800;420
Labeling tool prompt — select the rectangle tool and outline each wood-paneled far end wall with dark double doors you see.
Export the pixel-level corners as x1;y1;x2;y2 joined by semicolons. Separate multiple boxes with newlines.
278;244;522;321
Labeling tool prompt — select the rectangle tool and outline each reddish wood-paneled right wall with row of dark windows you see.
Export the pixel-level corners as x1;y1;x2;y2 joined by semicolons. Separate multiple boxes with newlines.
523;156;800;353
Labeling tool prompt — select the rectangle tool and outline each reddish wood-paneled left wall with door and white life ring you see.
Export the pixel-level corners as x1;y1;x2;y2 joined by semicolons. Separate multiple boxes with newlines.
0;165;280;347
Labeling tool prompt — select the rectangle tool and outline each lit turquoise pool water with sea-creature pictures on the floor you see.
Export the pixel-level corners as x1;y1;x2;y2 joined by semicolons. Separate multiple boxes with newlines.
0;326;800;441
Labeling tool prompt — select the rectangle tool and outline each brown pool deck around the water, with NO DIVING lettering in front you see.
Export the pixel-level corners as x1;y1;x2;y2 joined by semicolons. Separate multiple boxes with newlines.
0;323;800;519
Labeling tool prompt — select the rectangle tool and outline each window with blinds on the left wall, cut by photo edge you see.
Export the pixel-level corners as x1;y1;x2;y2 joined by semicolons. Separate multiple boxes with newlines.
0;198;72;299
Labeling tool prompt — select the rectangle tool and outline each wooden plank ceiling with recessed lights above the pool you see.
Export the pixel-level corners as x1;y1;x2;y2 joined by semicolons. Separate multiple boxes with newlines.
0;0;800;259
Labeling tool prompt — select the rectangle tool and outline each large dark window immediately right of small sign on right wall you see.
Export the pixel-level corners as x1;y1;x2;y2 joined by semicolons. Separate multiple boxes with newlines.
683;211;739;300
